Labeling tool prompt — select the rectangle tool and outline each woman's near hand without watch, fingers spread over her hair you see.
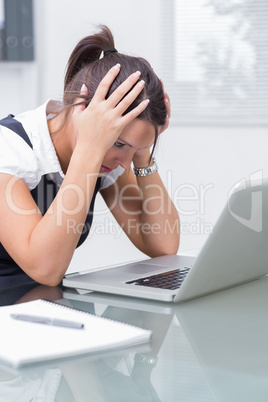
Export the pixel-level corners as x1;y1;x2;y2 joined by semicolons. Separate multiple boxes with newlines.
72;64;148;155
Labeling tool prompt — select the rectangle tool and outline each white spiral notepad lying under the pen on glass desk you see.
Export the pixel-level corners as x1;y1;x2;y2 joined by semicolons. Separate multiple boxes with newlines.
0;299;152;368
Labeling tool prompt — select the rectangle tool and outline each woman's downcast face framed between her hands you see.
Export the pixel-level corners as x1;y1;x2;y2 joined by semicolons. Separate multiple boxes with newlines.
100;119;155;173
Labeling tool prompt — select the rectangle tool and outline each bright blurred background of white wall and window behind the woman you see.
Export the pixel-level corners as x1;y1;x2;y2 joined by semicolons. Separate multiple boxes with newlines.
0;0;268;272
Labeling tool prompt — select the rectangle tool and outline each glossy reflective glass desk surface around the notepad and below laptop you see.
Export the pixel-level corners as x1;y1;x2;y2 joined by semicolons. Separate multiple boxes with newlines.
0;277;268;402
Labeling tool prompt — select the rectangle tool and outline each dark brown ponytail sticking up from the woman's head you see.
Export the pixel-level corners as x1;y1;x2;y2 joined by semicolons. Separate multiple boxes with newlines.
64;25;114;89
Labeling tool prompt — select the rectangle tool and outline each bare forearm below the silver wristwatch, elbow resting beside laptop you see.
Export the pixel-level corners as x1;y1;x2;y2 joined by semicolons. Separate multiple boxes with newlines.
101;157;180;257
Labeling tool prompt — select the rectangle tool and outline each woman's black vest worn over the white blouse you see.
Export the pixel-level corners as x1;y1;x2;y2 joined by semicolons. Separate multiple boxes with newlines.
0;115;101;289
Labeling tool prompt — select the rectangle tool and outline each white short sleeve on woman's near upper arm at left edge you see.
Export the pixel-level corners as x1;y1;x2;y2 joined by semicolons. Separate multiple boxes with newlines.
0;126;39;190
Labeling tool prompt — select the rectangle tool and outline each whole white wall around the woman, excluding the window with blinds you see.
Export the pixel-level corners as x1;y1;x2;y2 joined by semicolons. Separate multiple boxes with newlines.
0;0;268;271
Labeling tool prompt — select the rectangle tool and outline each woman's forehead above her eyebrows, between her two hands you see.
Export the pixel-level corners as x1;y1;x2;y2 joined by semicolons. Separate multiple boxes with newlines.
118;119;155;148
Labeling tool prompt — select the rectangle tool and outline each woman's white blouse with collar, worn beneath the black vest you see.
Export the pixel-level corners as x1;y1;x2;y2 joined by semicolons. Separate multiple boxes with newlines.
0;100;124;190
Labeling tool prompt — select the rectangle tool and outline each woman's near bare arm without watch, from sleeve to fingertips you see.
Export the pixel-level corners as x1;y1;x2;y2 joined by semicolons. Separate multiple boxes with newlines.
0;66;147;286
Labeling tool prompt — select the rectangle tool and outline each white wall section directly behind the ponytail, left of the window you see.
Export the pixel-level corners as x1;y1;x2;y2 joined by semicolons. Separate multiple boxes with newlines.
35;0;161;105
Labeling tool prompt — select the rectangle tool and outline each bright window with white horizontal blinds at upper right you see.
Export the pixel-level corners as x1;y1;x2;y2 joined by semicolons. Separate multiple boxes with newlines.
162;0;268;126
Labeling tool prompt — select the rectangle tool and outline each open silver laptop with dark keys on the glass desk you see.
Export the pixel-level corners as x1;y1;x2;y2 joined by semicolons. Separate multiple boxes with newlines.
63;179;268;303
